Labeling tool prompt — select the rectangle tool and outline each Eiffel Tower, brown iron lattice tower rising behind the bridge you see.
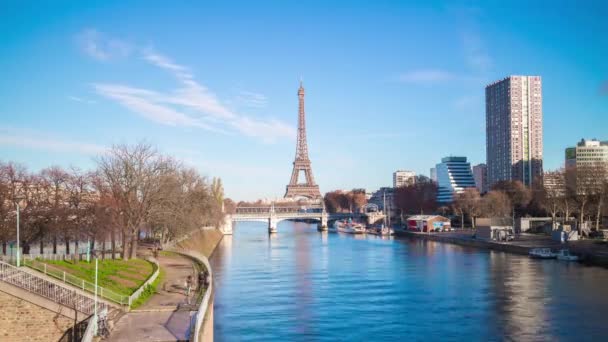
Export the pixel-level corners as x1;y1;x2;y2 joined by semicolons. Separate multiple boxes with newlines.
285;81;321;199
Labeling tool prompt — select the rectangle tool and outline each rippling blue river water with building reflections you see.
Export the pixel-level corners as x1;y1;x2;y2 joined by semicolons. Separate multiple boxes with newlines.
211;221;608;341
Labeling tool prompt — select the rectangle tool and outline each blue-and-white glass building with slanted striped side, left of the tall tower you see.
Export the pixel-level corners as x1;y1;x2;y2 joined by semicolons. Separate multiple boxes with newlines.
435;157;475;204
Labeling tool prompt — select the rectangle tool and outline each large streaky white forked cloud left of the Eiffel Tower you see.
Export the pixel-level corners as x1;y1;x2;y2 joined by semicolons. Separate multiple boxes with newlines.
93;49;296;143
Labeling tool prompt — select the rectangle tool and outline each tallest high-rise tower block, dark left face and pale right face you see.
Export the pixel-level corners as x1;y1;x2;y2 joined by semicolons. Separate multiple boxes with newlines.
486;76;543;187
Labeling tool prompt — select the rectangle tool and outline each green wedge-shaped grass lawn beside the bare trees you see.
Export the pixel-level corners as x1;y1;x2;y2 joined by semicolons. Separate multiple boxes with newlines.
41;259;156;295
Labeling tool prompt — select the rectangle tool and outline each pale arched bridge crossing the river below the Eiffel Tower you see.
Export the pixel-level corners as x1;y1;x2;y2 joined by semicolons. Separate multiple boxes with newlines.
220;203;384;235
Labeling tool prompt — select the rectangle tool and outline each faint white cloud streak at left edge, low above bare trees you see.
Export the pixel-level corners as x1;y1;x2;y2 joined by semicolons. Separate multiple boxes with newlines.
0;128;107;155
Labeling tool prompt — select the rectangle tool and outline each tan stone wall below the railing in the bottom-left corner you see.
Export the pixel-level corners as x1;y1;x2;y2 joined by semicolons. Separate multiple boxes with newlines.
0;284;73;342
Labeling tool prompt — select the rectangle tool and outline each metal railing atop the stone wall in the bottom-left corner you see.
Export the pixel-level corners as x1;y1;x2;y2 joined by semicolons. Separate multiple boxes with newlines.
0;261;107;315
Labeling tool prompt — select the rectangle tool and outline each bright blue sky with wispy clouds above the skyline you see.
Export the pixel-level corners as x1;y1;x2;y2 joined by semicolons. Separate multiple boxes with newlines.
0;1;608;200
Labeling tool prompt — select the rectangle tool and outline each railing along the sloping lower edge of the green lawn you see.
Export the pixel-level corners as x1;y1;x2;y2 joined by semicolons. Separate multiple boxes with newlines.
23;258;130;305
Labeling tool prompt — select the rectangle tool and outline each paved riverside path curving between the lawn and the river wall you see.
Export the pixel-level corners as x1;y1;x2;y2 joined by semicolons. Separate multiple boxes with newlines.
109;255;197;342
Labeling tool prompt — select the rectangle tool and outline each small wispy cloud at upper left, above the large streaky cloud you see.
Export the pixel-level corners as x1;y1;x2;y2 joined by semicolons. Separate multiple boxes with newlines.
77;29;133;61
